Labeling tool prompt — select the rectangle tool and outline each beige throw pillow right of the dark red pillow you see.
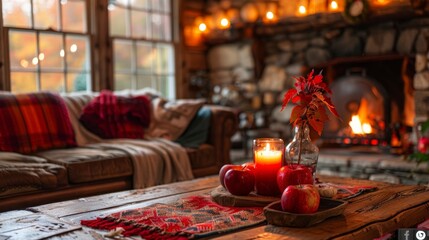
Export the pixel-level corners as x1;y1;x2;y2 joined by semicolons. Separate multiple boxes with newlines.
146;98;205;141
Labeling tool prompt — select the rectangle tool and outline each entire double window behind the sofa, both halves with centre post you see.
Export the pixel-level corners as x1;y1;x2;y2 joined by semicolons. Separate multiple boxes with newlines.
0;0;176;98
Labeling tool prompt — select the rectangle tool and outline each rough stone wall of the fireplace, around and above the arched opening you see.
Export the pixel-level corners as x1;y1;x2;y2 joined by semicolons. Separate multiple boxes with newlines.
208;18;429;128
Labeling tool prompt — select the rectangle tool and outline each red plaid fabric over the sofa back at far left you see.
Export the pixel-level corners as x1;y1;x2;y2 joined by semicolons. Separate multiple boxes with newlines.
0;92;76;153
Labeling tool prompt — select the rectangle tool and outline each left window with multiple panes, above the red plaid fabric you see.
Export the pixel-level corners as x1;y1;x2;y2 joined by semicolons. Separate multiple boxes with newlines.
2;0;91;92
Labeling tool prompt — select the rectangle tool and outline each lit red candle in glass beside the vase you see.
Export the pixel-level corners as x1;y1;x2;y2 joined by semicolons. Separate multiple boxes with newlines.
253;138;284;196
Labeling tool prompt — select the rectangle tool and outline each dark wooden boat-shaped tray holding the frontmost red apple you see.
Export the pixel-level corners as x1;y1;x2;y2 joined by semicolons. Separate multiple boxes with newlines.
264;198;347;227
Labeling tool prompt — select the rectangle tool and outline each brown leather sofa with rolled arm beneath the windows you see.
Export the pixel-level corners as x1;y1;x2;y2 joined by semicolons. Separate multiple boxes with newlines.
0;92;238;212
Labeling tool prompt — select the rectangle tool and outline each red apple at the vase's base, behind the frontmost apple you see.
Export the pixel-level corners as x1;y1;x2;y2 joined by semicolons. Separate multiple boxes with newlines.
277;165;314;193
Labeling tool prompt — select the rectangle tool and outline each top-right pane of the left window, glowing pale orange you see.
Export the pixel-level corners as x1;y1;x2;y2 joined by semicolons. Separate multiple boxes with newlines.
61;0;88;33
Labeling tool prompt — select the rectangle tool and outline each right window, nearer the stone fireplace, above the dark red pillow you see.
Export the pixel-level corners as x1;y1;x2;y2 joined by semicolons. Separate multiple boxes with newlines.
109;0;175;98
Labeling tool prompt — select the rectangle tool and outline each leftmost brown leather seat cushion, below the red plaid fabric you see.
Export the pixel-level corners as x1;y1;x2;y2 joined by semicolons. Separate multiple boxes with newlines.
0;152;67;196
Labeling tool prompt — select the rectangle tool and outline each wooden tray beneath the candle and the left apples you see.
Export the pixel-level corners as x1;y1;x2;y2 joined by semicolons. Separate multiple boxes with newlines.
210;185;280;207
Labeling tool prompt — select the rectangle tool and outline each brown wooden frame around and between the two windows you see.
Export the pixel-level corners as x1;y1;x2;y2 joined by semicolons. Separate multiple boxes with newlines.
0;0;178;98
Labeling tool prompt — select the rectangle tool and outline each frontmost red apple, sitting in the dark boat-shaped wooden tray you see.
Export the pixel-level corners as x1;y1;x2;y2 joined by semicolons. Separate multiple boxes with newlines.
280;184;320;213
